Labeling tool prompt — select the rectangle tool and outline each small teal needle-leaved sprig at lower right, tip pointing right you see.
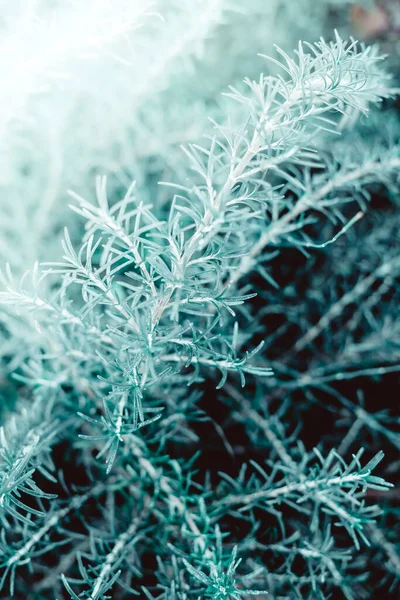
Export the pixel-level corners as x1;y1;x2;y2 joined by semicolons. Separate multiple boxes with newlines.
222;449;391;548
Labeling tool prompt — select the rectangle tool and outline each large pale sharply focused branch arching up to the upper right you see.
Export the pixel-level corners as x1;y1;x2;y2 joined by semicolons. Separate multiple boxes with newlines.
2;35;391;476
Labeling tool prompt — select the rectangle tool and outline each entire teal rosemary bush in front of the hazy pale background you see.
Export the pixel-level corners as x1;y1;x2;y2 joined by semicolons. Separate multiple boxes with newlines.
0;2;400;600
